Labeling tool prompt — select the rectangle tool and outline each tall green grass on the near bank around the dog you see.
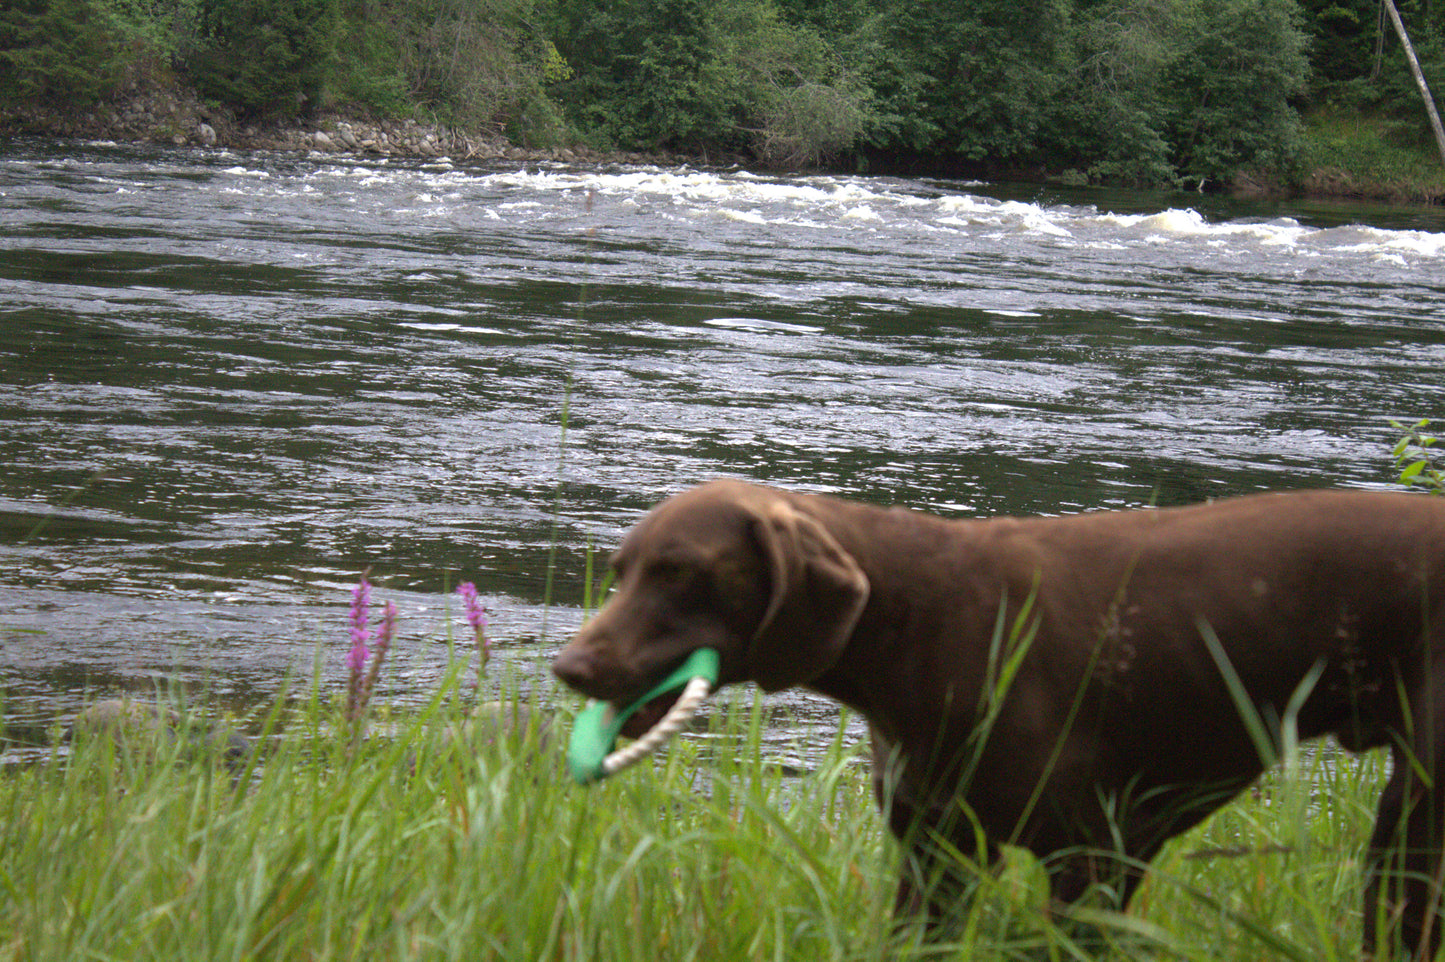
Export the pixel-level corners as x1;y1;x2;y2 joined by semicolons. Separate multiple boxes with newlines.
0;673;1384;962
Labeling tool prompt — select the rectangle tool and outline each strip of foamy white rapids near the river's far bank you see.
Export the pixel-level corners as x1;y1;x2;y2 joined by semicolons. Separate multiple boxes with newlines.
132;155;1445;267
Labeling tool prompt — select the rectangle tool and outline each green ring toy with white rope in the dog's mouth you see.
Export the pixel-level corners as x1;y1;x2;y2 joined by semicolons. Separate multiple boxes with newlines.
566;649;720;784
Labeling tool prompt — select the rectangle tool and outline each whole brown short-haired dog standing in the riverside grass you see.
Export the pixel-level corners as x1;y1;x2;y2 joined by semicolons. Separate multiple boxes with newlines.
553;481;1445;958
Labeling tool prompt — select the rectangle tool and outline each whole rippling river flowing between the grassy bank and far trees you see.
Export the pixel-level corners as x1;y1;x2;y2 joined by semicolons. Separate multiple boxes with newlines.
0;142;1445;758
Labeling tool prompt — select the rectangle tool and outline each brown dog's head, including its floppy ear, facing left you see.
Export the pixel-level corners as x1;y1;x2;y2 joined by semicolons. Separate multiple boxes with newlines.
552;481;868;722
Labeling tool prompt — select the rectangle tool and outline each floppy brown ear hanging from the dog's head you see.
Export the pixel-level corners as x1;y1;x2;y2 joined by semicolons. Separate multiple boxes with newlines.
747;501;868;692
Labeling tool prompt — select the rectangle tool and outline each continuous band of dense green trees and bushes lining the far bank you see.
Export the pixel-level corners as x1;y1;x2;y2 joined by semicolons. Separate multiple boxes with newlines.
0;0;1445;185
